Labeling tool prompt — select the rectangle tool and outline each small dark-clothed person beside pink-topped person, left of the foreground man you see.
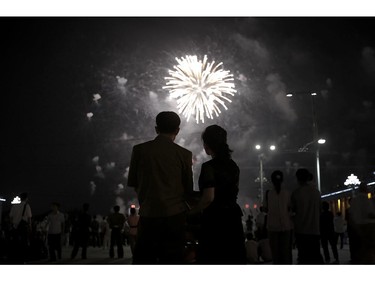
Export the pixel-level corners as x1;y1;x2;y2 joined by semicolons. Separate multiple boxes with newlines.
107;205;125;259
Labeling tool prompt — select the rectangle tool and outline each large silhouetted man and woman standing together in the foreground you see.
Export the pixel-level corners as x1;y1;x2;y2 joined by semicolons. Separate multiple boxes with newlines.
128;111;246;264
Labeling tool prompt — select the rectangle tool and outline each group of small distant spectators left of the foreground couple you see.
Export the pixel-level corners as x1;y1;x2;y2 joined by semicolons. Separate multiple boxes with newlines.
0;193;139;264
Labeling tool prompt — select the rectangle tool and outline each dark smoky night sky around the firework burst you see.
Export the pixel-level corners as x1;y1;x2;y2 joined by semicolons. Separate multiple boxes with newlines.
0;17;375;214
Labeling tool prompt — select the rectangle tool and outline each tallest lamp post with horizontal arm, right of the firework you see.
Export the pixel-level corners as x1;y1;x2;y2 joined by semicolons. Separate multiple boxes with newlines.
286;92;322;192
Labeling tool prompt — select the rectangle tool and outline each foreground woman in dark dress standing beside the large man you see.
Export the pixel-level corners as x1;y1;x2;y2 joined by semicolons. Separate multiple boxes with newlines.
191;125;247;264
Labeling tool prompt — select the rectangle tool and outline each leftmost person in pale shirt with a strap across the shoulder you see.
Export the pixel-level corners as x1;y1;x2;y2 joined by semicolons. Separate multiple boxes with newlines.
9;192;32;263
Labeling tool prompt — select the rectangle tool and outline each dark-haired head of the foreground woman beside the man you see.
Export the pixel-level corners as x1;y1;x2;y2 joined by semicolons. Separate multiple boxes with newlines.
202;125;232;158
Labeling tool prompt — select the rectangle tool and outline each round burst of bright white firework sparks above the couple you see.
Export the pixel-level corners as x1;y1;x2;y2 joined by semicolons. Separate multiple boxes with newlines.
163;56;236;123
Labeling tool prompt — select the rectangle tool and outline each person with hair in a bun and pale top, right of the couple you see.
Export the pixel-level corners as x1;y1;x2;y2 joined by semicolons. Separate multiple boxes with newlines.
263;170;293;264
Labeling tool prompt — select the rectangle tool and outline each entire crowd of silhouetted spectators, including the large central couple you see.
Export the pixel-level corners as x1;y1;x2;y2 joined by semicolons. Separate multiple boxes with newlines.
0;111;375;264
